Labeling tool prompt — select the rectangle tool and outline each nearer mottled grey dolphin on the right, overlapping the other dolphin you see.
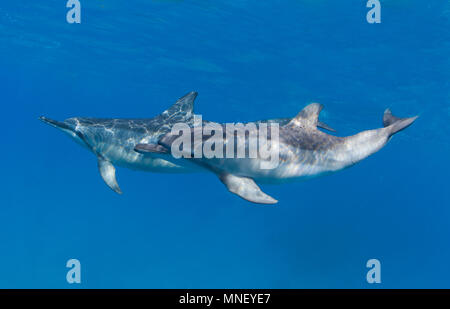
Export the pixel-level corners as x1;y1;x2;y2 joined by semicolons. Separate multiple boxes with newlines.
135;103;417;204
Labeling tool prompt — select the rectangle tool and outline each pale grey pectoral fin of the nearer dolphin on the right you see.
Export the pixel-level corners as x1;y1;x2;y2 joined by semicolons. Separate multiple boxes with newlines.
219;173;278;204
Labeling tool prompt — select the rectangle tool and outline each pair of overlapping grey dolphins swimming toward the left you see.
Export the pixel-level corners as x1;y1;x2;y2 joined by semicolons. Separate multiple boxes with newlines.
40;92;417;204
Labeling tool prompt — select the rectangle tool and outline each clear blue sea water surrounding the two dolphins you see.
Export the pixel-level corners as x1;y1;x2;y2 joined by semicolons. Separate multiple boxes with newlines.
0;0;450;288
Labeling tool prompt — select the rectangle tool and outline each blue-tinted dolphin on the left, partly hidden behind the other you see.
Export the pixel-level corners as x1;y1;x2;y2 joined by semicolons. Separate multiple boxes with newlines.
39;91;310;194
